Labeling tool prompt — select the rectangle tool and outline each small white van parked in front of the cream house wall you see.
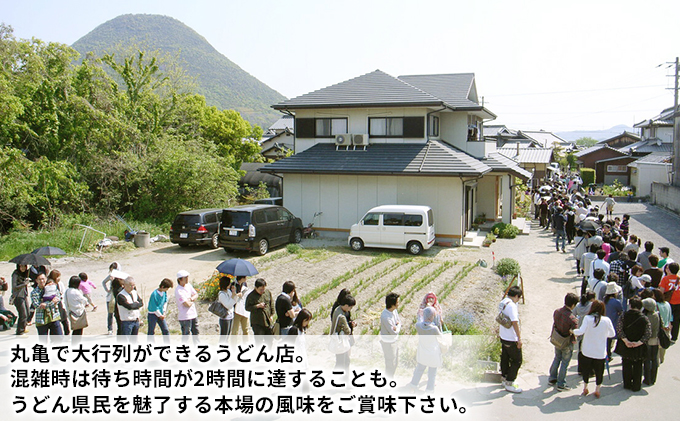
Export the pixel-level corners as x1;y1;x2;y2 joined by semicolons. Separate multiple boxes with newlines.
347;205;434;254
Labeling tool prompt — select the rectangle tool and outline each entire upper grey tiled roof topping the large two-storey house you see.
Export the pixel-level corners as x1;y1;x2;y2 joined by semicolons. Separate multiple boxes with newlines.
272;70;495;117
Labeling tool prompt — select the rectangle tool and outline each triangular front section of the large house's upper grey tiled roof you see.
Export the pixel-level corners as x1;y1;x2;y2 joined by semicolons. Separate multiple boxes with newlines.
272;70;442;110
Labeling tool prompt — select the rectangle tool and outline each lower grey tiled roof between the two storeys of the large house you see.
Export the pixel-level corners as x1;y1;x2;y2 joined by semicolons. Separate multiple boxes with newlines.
260;140;491;176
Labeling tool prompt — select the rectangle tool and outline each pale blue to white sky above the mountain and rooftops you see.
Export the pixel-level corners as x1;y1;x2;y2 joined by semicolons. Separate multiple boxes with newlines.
0;0;680;131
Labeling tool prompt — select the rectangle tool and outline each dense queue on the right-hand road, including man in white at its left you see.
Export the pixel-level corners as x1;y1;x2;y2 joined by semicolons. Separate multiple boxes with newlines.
499;176;680;398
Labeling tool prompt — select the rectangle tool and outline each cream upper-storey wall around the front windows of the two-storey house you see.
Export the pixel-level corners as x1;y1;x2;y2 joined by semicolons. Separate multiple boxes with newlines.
295;107;430;153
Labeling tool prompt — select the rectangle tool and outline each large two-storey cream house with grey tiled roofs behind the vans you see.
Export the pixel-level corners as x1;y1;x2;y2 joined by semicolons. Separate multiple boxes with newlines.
261;70;530;244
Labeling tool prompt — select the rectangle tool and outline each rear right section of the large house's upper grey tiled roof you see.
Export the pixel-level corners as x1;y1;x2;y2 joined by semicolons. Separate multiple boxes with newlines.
399;73;479;108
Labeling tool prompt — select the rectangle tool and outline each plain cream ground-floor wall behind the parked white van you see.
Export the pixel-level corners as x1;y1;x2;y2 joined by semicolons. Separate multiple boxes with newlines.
283;174;463;243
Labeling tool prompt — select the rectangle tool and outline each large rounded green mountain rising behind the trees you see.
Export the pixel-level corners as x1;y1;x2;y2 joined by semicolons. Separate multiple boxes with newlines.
73;15;286;129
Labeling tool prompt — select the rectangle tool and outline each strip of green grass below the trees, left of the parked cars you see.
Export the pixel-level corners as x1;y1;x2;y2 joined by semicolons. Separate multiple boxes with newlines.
0;215;170;261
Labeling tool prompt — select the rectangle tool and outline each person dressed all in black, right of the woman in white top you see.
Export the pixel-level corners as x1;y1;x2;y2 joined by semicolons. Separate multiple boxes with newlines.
614;297;652;392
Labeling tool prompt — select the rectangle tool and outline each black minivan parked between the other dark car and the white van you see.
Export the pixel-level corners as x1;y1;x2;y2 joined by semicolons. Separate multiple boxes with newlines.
218;205;302;255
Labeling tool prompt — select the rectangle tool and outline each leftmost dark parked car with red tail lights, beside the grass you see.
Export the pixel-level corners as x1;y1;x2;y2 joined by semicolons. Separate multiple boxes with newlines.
170;209;222;249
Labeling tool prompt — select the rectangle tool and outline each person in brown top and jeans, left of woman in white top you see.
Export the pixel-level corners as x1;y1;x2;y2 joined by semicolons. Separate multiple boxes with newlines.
548;292;578;391
